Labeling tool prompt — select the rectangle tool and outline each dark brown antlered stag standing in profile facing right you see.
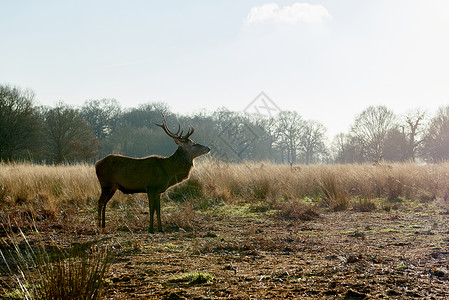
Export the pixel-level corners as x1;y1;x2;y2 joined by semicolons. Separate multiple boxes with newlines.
95;114;210;233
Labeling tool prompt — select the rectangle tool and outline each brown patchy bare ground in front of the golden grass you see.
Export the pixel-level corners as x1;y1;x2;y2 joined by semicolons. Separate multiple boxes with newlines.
0;205;449;299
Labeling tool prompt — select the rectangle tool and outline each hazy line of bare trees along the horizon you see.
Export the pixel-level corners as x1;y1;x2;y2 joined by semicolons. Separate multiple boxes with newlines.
0;85;449;164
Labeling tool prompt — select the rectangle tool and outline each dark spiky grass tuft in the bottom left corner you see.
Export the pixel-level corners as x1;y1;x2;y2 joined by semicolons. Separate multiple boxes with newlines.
0;229;110;299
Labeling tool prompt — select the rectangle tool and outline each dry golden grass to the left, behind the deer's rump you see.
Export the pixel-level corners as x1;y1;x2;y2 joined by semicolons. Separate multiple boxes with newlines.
0;163;139;232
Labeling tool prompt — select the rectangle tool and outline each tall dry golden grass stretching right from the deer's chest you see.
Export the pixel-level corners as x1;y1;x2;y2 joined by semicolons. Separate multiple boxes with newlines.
192;160;449;210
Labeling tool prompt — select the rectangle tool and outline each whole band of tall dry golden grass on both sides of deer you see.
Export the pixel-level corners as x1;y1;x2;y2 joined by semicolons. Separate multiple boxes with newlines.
0;158;449;230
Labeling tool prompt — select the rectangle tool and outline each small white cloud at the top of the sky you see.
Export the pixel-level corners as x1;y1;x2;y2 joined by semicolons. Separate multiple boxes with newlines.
245;2;332;24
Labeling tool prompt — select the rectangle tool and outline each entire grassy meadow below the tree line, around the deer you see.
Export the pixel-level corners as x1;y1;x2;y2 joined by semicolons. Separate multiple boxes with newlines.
0;159;449;299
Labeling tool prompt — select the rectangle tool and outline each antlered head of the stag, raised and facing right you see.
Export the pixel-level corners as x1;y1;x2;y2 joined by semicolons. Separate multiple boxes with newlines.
155;113;210;160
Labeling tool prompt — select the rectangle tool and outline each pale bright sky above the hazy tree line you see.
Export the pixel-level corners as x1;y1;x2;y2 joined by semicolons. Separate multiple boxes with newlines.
0;0;449;135
